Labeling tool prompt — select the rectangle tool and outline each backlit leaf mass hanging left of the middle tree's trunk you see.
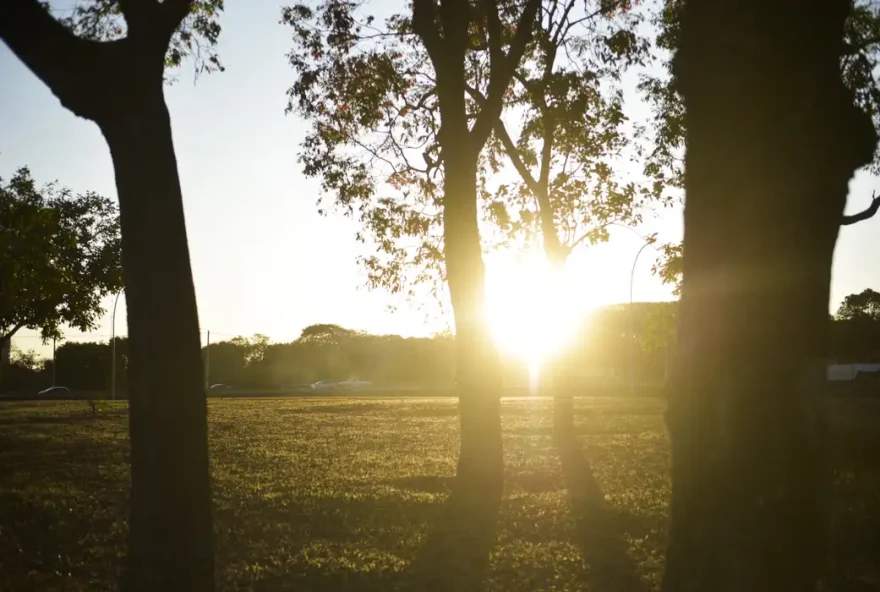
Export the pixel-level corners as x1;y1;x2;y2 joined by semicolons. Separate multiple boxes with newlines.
282;0;442;294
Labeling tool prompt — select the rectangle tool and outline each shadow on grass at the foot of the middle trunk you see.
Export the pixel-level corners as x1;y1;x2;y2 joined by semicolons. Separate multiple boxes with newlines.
404;479;501;592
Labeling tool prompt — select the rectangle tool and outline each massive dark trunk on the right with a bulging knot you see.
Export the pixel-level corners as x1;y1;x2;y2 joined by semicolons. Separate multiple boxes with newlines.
663;0;876;592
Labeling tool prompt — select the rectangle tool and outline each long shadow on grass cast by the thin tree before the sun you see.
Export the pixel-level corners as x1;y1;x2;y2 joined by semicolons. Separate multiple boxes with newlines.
554;431;648;592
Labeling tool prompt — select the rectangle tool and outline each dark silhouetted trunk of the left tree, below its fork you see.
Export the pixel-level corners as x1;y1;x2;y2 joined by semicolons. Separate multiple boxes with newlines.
99;76;214;591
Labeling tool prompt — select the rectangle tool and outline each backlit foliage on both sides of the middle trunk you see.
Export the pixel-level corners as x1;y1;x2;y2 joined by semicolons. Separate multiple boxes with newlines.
282;0;624;310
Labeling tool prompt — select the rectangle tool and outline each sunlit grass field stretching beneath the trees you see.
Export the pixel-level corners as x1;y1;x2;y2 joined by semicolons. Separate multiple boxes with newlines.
0;398;880;592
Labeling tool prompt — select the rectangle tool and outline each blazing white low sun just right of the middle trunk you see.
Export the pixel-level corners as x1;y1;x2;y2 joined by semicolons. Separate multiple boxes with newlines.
486;253;590;375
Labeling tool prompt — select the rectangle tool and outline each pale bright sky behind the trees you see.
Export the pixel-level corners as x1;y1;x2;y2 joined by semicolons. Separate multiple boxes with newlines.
0;0;880;355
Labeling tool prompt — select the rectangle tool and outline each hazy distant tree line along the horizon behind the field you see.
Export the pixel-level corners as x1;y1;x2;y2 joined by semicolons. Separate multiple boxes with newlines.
6;289;880;393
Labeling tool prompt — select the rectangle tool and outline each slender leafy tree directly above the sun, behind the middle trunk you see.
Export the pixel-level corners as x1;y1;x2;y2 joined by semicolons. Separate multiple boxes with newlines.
482;0;663;431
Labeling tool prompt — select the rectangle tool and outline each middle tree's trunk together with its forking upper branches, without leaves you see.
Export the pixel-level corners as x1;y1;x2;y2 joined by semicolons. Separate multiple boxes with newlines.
412;0;540;497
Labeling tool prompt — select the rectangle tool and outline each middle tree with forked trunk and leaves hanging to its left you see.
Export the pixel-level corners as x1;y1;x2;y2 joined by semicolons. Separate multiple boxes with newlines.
283;0;540;492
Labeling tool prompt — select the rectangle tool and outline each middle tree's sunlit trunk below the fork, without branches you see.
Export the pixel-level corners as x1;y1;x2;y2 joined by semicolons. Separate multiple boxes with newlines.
443;151;504;494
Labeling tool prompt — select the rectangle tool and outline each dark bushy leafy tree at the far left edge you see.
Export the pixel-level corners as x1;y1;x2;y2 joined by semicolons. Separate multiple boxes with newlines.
0;168;122;340
